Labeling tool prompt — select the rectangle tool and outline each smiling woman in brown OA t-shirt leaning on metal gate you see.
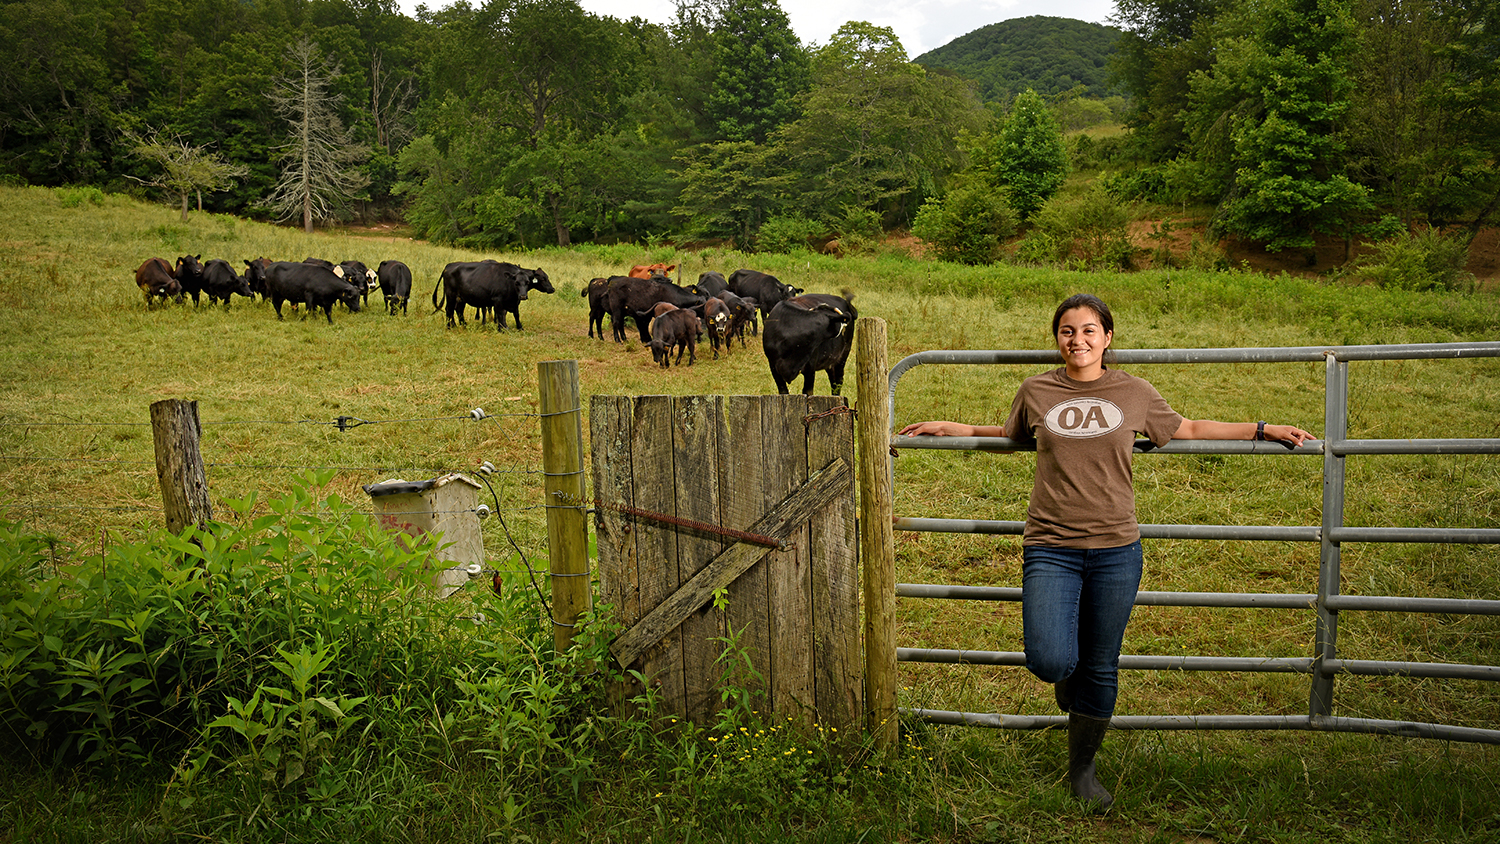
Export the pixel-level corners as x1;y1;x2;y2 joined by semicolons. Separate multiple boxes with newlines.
902;294;1314;811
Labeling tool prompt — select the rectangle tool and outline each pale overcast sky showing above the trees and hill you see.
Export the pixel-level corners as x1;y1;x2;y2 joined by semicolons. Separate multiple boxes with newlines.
401;0;1115;58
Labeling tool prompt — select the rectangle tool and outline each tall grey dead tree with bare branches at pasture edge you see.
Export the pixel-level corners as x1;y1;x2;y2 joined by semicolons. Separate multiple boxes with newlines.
266;36;369;232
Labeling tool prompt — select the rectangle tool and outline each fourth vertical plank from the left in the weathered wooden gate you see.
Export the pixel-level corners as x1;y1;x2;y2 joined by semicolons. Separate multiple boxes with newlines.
719;396;774;711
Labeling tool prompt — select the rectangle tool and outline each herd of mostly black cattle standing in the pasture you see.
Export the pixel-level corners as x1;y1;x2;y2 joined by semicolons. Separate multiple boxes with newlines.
135;255;858;396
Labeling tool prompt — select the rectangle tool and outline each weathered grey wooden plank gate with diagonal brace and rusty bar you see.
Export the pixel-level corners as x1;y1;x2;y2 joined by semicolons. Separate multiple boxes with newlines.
590;396;864;727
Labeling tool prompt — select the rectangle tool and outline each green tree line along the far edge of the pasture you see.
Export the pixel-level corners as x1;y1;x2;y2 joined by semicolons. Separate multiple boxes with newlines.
0;0;1500;259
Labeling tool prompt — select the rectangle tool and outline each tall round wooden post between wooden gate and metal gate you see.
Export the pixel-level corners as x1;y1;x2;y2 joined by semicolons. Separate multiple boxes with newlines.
855;316;897;750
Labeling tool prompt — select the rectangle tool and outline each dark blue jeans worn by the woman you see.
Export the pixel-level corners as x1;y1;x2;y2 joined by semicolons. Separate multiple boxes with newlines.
1022;540;1142;718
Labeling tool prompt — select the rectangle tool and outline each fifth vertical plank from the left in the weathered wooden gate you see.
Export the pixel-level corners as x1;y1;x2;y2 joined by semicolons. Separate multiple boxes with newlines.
761;396;816;720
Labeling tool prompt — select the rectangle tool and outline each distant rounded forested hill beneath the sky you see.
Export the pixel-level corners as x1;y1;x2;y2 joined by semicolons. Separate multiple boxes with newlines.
914;15;1121;103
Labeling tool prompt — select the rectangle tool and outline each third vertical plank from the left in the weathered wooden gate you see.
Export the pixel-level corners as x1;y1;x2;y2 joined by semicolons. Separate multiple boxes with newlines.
672;396;728;724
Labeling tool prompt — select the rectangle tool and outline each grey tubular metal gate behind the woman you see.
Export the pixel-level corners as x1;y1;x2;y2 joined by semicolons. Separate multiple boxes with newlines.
890;342;1500;744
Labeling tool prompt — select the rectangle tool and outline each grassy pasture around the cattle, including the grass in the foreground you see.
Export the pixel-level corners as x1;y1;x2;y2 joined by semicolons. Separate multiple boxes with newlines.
0;187;1500;843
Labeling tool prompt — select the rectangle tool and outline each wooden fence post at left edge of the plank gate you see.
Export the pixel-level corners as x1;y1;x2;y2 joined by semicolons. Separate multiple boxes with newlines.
537;360;591;654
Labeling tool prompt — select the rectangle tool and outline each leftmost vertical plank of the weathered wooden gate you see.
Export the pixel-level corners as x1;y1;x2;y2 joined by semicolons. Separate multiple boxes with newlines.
588;396;642;712
